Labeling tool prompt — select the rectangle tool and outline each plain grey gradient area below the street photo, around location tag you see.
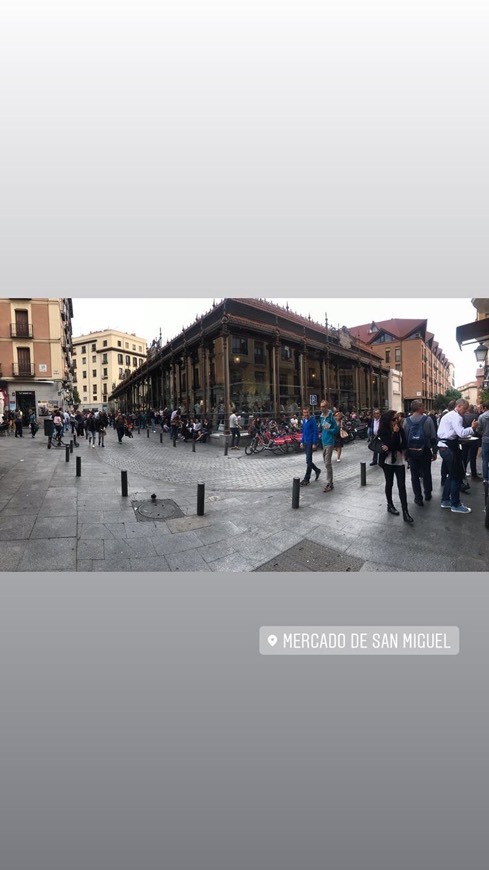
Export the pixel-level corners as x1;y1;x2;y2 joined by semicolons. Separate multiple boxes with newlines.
0;573;489;870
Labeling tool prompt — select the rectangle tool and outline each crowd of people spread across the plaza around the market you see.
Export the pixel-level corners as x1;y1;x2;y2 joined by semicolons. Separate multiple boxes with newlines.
4;399;489;523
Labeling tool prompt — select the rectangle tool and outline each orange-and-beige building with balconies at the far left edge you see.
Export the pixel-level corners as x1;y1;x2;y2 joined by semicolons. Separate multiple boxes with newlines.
0;298;73;419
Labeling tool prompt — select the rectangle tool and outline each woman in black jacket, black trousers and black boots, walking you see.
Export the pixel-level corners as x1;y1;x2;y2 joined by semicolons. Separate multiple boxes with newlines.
378;411;414;523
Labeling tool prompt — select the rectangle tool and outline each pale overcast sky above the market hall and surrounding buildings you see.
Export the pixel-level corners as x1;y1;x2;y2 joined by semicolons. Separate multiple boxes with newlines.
73;297;477;386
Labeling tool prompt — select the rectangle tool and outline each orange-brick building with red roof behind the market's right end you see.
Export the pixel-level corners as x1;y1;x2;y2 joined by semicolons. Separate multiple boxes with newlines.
349;318;453;413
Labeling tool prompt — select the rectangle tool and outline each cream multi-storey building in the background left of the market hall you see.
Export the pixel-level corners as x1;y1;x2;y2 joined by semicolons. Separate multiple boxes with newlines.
73;329;147;411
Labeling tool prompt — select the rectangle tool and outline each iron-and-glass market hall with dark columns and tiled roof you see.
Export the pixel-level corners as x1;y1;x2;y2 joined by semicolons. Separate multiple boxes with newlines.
111;298;389;422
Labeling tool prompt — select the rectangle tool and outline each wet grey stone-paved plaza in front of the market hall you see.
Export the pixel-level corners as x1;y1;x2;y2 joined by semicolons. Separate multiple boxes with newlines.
0;429;489;572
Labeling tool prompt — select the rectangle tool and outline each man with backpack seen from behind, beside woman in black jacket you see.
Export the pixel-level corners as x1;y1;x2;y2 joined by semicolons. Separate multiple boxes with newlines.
404;399;437;507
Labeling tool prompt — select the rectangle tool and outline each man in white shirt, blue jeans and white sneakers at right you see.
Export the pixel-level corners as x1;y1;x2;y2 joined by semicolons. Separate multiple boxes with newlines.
437;399;477;514
